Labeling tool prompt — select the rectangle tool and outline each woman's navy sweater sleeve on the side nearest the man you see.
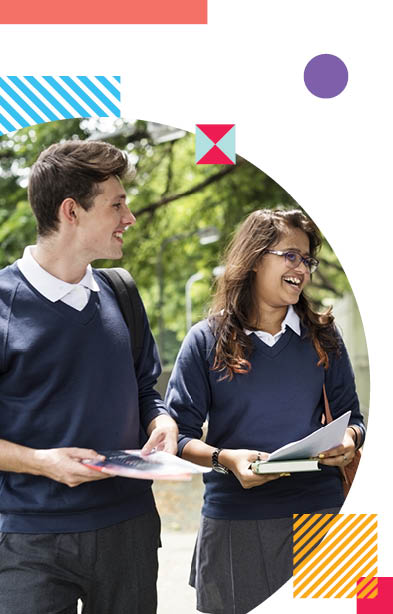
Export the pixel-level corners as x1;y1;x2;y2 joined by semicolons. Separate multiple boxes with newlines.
165;322;214;456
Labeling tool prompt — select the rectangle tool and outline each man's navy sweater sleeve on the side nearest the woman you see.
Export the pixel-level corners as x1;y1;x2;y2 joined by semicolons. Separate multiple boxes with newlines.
135;311;167;430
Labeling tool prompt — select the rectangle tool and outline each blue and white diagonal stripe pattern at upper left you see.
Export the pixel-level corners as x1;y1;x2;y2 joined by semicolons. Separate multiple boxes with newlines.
0;76;120;134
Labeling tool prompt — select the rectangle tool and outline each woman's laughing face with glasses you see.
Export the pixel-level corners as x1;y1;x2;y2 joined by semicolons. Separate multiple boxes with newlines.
254;228;310;310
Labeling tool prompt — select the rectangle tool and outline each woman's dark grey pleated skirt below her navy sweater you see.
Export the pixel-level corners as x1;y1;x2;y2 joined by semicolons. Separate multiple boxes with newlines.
190;508;339;614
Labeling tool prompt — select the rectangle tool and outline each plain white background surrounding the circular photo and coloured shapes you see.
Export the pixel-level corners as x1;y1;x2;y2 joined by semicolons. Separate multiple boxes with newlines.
0;0;393;614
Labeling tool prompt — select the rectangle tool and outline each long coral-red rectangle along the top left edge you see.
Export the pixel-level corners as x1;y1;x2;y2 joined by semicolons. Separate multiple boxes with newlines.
1;0;207;24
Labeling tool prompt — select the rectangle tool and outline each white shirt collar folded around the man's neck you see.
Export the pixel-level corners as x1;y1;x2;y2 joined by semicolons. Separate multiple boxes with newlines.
17;245;100;303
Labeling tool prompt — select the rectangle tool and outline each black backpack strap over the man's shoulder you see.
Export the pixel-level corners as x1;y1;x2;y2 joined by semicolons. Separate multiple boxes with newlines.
97;267;144;367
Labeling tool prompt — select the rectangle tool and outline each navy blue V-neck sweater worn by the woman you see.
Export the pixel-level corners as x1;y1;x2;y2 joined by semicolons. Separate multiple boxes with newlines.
165;321;363;520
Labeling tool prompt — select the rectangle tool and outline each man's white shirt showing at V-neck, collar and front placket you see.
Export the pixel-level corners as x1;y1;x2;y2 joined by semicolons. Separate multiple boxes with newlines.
16;245;100;311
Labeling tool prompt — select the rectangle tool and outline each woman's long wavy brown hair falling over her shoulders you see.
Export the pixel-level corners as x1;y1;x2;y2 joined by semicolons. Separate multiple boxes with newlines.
209;209;339;380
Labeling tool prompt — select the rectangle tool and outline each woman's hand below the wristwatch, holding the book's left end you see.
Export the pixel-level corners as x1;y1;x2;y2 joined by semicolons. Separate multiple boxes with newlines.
218;449;281;488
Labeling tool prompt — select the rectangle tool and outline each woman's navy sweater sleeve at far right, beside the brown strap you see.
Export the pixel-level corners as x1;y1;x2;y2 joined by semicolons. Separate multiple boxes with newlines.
325;337;366;443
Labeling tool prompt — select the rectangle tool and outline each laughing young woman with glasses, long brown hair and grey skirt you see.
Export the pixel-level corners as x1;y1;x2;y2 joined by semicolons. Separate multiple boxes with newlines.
166;210;365;614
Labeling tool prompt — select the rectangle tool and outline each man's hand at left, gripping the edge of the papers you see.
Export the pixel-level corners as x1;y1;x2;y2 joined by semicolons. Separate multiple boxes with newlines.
34;448;112;488
